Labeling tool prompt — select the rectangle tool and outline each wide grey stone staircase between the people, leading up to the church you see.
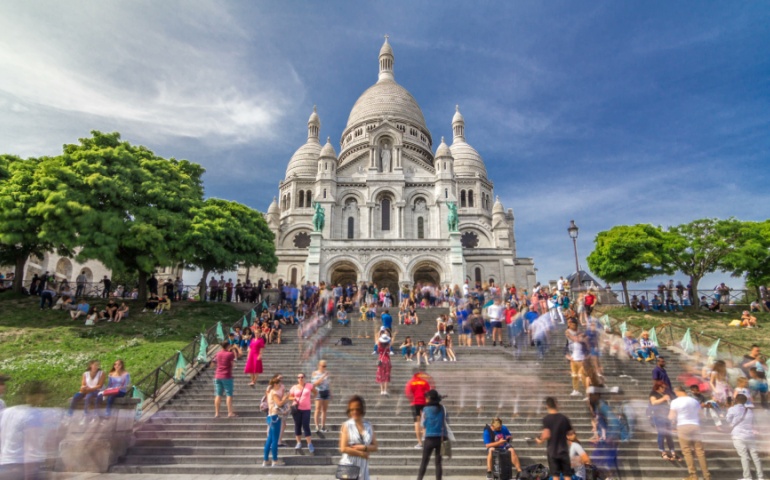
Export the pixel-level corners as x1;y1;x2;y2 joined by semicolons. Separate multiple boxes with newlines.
111;308;764;480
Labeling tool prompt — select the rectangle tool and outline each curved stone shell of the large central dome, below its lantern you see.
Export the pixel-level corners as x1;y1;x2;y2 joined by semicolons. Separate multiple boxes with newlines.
345;80;428;130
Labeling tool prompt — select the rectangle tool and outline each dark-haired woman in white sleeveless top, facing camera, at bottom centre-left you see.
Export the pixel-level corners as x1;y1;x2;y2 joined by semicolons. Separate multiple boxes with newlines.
340;395;377;480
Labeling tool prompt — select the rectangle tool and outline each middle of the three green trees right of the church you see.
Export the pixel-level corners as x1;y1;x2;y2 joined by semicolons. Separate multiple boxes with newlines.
664;218;741;305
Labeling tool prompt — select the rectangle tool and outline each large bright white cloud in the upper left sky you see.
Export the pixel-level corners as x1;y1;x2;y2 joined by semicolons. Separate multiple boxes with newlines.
0;1;304;154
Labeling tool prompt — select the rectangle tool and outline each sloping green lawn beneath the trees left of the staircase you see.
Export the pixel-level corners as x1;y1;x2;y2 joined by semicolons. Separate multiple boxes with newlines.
0;293;243;405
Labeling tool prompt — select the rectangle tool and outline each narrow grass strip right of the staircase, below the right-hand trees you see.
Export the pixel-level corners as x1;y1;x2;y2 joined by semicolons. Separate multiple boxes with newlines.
597;306;770;355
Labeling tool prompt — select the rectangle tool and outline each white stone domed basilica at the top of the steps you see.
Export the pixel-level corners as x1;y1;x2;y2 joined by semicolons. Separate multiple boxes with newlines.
250;38;535;290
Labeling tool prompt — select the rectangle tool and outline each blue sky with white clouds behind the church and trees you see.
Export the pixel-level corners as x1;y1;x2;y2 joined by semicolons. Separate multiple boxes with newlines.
0;0;770;287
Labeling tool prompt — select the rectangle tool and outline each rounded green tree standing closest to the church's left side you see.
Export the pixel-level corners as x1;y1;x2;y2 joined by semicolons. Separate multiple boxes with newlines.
183;198;278;299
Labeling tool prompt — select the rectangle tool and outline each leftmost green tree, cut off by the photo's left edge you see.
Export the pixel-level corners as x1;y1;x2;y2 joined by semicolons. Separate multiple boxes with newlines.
0;155;74;293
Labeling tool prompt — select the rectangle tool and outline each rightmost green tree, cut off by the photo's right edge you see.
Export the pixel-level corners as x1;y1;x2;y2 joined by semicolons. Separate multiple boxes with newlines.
722;220;770;297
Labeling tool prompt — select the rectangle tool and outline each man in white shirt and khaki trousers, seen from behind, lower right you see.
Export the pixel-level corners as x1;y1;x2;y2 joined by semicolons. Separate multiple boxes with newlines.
668;386;711;480
